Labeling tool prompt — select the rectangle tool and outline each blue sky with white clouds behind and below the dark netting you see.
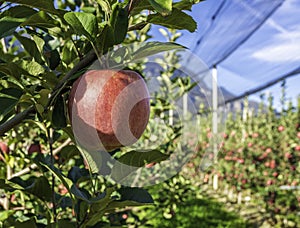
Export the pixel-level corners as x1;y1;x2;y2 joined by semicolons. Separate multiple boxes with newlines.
151;0;300;109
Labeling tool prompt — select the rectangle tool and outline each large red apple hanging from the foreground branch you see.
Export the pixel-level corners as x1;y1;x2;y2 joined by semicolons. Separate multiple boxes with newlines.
68;70;150;151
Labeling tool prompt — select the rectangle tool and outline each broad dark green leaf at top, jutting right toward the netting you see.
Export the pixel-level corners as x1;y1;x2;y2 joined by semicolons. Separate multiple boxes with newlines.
147;9;197;32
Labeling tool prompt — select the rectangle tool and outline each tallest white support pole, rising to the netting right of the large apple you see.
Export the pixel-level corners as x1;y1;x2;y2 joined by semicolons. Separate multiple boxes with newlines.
212;66;218;190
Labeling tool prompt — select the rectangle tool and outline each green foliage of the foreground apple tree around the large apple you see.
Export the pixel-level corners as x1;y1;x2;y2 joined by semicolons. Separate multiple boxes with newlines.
0;0;199;227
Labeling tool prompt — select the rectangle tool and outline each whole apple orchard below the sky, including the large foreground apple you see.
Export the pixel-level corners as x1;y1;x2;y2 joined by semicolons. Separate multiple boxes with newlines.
0;0;300;227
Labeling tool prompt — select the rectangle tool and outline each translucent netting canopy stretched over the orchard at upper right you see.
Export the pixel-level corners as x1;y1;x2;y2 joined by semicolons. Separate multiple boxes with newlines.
165;0;300;108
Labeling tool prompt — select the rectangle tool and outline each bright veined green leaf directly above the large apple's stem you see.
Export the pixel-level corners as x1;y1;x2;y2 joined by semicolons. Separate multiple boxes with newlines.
64;12;98;42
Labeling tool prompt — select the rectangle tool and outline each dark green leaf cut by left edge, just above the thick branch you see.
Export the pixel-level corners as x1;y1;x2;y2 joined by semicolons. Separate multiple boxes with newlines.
0;88;23;120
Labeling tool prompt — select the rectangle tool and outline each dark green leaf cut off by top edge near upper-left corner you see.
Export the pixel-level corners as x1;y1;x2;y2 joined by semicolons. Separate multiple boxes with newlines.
9;0;63;15
